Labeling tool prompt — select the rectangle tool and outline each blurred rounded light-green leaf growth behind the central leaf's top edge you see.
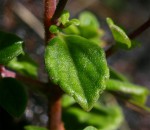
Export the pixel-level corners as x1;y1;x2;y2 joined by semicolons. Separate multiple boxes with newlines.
63;11;104;45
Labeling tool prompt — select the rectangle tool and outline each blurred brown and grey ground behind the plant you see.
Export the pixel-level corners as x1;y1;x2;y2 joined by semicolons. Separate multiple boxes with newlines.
0;0;150;130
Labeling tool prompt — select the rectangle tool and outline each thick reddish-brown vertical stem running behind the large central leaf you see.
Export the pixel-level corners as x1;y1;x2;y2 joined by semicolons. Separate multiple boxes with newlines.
44;0;67;130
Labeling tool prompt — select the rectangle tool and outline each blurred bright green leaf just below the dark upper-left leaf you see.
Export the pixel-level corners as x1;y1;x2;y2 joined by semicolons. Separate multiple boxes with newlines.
7;54;38;78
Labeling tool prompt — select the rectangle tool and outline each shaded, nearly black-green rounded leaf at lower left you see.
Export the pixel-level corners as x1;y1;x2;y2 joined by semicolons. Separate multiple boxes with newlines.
0;78;27;117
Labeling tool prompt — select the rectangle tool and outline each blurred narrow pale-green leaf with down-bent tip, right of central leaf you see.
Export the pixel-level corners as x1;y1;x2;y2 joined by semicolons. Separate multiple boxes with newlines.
106;79;150;104
